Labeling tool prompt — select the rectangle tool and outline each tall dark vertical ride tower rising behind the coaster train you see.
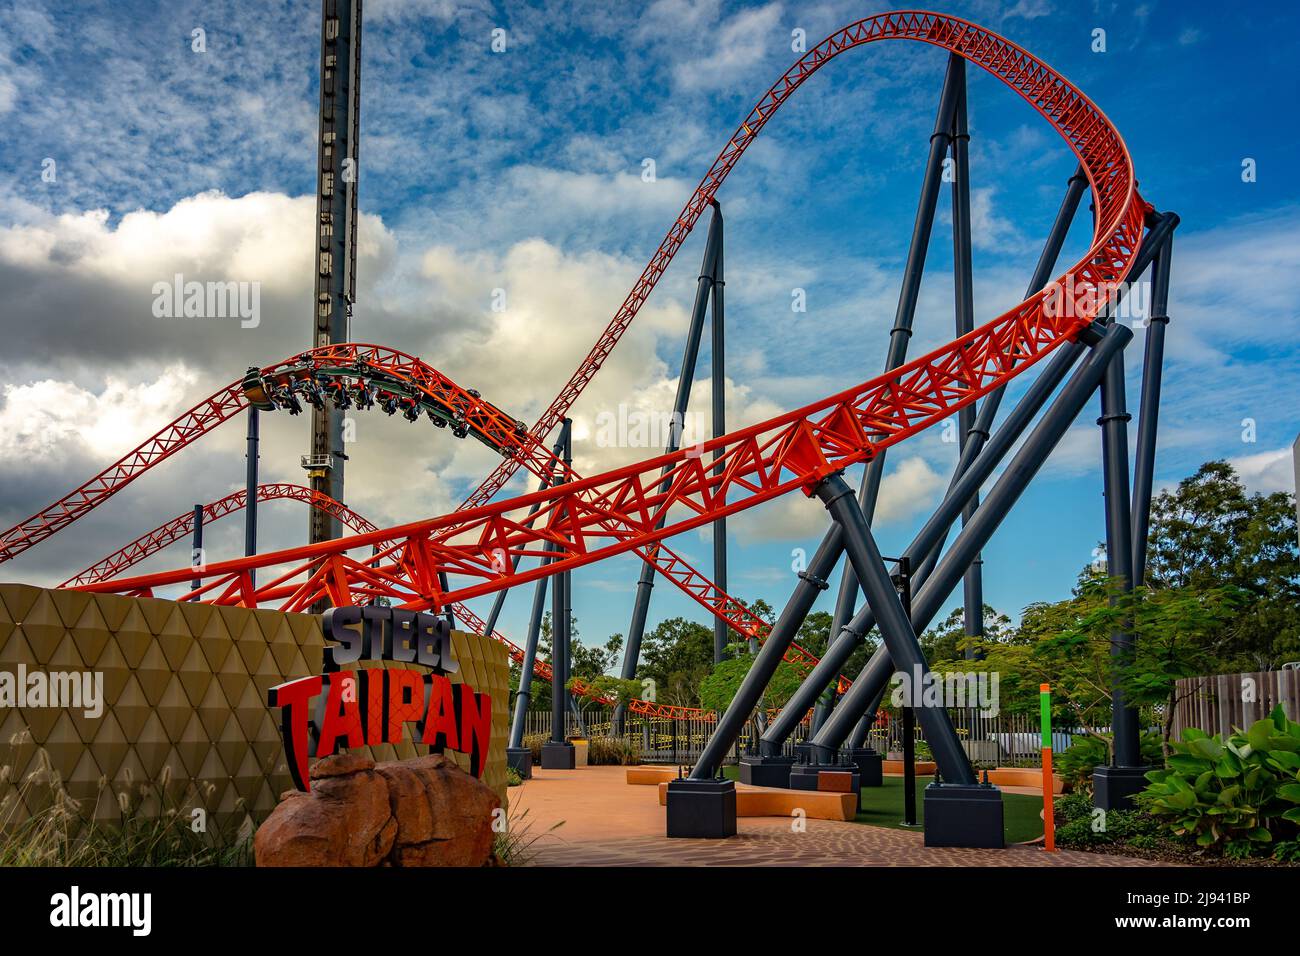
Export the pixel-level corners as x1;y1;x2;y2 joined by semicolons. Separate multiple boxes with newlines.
303;0;361;544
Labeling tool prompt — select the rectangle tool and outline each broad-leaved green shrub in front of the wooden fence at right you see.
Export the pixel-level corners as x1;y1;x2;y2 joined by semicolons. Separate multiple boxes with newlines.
1138;706;1300;858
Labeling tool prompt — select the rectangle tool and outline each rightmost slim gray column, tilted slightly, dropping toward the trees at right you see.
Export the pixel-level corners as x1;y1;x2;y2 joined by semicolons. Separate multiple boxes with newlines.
1132;221;1178;587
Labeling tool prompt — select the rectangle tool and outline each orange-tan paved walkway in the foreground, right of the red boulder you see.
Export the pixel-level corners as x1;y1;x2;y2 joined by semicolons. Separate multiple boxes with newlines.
510;767;1156;866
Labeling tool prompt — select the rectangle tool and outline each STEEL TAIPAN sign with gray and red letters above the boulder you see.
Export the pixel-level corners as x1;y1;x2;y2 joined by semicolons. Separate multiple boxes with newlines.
268;605;491;791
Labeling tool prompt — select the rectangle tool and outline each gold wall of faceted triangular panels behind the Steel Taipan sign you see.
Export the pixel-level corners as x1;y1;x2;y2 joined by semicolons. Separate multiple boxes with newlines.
0;584;510;825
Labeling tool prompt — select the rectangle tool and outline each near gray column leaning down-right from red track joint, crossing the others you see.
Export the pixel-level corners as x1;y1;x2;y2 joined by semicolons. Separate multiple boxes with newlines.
816;473;976;784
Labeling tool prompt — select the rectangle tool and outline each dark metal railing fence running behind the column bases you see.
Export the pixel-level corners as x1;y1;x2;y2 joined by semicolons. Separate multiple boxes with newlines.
524;705;1079;767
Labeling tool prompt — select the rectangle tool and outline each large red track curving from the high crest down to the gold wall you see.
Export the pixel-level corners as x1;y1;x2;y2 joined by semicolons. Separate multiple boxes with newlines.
73;13;1148;629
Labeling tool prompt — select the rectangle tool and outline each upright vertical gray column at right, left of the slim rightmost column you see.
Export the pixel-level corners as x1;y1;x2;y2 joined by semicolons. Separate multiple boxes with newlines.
1097;354;1141;767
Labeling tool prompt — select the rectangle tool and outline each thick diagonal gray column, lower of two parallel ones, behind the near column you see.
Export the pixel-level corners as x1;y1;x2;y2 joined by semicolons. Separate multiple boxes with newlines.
813;325;1132;754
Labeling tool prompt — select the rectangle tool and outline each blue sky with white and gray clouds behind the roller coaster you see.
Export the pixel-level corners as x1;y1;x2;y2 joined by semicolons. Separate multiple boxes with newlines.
0;0;1300;658
